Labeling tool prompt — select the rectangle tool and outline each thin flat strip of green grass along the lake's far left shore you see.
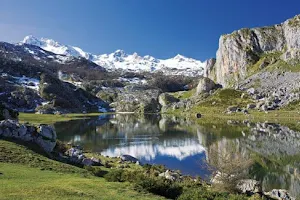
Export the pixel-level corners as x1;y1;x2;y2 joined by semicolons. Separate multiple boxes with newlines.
19;113;103;124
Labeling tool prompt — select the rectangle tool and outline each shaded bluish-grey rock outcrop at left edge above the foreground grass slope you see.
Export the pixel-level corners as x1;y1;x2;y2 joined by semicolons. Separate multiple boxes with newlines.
0;119;56;153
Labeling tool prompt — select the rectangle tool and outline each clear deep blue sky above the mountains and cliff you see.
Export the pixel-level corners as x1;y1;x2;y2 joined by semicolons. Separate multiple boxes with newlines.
0;0;300;61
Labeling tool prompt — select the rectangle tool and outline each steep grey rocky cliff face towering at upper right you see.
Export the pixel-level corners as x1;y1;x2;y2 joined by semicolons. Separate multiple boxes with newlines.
206;15;300;87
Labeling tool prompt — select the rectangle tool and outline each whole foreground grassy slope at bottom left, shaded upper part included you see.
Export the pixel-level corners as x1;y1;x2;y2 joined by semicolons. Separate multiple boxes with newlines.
0;140;163;200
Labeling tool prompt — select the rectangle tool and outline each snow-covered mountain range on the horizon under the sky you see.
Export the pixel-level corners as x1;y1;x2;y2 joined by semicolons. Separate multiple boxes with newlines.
21;36;206;76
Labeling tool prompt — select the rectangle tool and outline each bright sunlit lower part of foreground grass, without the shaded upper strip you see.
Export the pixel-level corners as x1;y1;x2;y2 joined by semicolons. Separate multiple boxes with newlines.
0;163;162;200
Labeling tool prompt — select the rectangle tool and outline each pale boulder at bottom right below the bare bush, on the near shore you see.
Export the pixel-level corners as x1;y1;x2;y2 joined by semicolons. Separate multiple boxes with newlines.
236;179;262;195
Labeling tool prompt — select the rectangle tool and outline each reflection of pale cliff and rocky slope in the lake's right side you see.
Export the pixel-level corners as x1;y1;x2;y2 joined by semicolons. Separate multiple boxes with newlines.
207;123;300;197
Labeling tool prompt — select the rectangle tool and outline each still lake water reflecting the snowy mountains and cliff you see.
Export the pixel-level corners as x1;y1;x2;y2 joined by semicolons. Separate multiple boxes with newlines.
55;114;300;197
